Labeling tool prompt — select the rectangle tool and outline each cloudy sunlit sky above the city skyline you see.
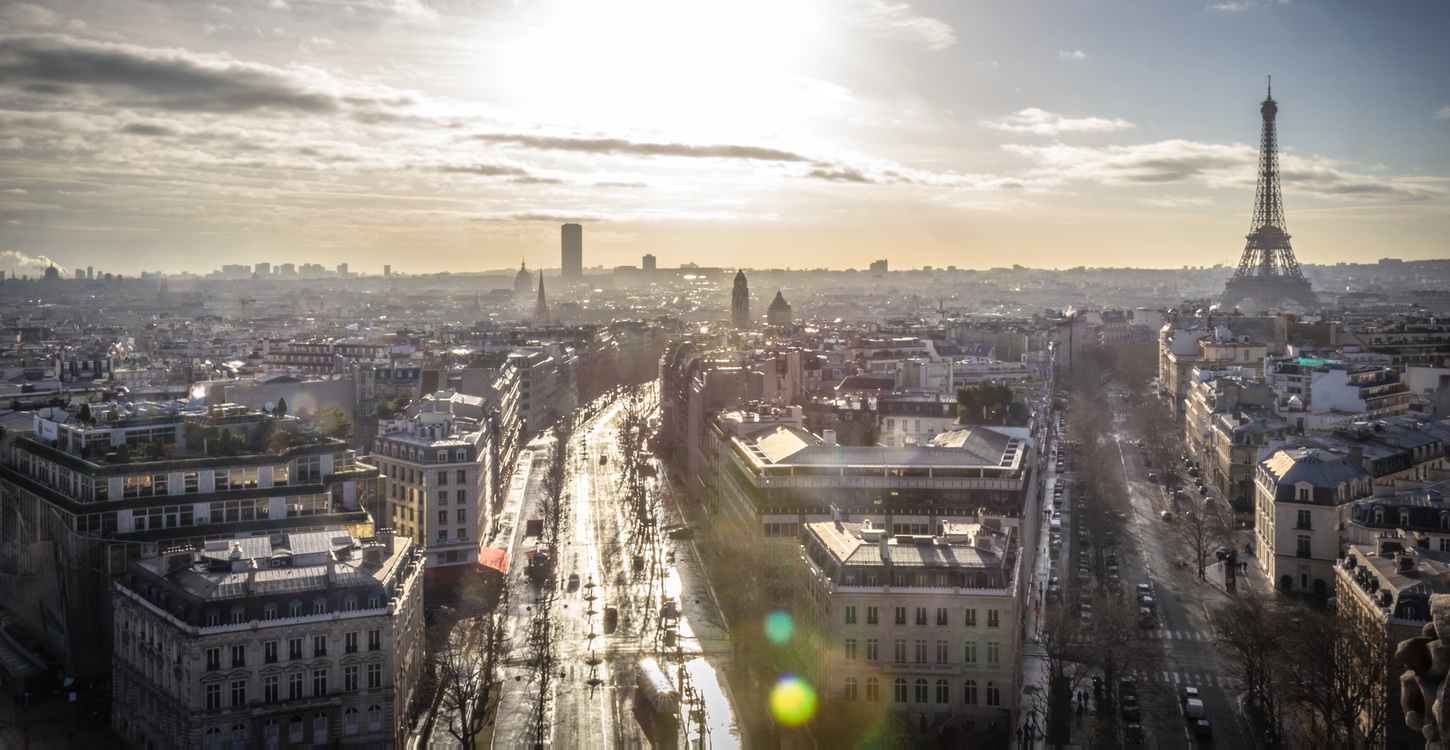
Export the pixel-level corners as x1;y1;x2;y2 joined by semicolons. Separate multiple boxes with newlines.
0;0;1450;274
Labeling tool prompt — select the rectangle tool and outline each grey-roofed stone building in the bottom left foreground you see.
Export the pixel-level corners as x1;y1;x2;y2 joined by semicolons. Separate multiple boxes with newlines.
110;531;423;750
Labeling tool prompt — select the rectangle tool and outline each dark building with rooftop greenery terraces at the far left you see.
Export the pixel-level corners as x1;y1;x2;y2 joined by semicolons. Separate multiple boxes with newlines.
0;403;377;679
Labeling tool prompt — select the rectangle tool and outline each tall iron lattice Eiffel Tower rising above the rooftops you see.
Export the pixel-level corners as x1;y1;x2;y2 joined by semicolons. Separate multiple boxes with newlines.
1219;78;1320;310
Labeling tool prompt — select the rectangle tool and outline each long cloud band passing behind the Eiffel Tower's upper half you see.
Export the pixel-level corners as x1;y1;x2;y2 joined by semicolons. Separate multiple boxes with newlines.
1002;141;1446;202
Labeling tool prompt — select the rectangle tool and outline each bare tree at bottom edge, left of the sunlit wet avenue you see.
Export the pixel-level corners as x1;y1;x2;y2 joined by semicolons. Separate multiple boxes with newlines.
431;598;508;749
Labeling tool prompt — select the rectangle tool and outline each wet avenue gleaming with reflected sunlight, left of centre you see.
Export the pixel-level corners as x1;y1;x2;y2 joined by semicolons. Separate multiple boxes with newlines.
494;396;741;747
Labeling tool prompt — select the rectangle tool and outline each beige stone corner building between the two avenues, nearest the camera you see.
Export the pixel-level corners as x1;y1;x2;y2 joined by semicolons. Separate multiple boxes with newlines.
798;514;1024;733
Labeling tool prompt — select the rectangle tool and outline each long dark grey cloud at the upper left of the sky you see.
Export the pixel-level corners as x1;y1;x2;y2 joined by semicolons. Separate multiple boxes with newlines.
0;38;338;113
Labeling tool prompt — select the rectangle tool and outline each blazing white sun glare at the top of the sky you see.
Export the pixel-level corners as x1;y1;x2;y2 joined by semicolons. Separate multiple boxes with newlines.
490;0;822;142
